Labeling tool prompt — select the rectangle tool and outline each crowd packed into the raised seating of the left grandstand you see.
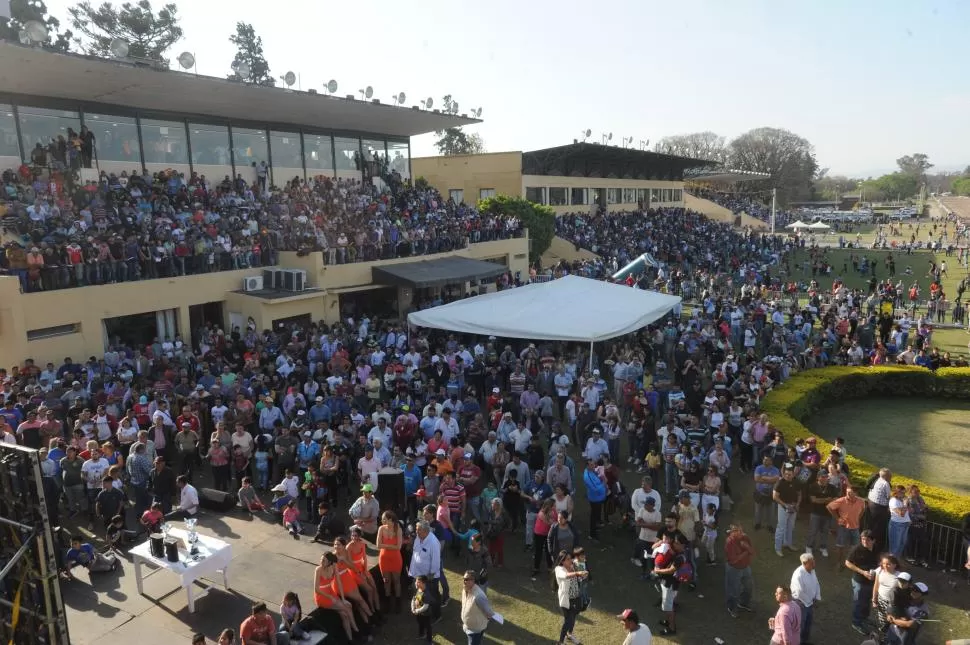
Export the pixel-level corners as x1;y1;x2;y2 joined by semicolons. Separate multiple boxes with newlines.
0;164;520;291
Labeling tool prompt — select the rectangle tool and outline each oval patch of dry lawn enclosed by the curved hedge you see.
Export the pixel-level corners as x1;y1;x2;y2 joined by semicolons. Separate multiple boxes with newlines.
808;398;970;495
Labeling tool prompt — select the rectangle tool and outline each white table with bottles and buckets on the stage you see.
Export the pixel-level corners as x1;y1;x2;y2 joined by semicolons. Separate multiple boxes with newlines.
129;527;232;613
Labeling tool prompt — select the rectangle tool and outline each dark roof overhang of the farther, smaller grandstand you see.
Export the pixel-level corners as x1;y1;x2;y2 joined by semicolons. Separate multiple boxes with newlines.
522;143;711;181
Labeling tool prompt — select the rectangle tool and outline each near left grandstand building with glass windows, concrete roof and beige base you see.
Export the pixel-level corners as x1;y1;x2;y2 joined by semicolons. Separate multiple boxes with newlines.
0;43;528;367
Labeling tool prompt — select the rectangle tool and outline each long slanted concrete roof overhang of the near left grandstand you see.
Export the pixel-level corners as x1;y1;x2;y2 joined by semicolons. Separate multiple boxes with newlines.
0;42;481;138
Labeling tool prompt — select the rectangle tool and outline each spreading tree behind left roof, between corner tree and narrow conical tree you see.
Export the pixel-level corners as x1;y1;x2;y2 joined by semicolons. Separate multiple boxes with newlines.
68;0;182;64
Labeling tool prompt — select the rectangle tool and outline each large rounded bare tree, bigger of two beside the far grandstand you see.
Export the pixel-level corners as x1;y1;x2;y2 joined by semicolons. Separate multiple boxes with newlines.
727;128;818;204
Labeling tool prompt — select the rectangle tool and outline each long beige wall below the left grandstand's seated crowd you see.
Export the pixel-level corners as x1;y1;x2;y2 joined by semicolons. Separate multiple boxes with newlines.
0;237;529;367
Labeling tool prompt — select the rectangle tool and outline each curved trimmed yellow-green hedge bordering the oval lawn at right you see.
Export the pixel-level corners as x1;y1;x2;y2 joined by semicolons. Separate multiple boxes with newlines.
761;366;970;527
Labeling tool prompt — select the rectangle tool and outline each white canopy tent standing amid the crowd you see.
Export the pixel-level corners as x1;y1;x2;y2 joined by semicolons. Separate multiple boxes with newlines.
408;275;680;343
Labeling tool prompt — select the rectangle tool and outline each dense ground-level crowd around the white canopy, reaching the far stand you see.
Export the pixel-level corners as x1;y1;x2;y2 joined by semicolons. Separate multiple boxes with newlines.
0;182;956;645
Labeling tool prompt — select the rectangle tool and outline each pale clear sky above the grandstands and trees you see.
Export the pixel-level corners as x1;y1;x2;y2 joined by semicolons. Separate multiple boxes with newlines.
48;0;970;175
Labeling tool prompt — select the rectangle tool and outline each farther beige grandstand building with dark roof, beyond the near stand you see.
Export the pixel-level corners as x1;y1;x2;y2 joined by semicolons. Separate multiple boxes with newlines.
411;142;710;214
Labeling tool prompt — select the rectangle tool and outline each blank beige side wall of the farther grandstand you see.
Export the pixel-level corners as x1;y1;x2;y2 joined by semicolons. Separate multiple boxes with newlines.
411;152;522;204
